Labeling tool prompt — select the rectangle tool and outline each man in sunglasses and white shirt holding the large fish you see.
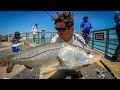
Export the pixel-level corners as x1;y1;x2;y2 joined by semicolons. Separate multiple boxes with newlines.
51;13;95;79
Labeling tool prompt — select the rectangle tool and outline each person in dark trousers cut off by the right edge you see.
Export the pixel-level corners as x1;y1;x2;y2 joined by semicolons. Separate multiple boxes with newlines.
112;11;120;60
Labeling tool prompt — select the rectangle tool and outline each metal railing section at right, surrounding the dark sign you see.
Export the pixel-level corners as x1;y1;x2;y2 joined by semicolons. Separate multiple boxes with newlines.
88;27;118;55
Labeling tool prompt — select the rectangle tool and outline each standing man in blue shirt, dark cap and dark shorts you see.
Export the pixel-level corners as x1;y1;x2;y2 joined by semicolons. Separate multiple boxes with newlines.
80;16;92;45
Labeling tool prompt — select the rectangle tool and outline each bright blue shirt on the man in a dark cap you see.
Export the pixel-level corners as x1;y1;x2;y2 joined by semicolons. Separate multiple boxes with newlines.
80;22;91;34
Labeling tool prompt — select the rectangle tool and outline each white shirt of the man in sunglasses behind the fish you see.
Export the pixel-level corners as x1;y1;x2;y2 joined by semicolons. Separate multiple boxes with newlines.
51;33;87;48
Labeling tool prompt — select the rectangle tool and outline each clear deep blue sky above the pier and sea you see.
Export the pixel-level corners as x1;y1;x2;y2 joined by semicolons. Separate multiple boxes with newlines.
0;11;115;34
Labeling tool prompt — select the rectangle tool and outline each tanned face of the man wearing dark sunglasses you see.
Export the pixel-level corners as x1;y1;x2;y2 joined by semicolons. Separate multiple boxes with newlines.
56;22;73;40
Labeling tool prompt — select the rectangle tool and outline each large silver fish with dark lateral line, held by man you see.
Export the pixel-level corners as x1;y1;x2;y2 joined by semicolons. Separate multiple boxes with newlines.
7;43;102;73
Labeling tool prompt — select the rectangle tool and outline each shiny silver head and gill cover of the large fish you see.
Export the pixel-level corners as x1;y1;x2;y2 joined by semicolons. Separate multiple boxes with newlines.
58;45;102;69
